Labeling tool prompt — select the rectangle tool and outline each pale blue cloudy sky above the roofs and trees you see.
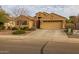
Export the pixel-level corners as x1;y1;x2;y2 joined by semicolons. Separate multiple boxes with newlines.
2;5;79;17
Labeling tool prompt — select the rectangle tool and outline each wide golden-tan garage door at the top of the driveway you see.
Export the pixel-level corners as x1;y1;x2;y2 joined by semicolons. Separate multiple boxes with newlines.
40;21;62;29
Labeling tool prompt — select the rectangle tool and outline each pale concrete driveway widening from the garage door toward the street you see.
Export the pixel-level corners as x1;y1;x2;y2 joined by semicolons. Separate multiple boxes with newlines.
26;30;67;40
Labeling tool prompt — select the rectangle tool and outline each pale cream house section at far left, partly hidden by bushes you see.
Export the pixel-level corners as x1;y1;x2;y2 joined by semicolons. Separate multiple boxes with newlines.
4;16;16;29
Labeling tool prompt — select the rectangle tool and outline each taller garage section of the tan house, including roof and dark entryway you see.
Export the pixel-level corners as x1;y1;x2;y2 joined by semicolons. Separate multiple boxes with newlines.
36;12;66;29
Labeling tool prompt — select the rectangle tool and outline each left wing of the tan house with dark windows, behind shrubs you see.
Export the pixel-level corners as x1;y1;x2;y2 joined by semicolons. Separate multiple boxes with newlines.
15;15;34;29
